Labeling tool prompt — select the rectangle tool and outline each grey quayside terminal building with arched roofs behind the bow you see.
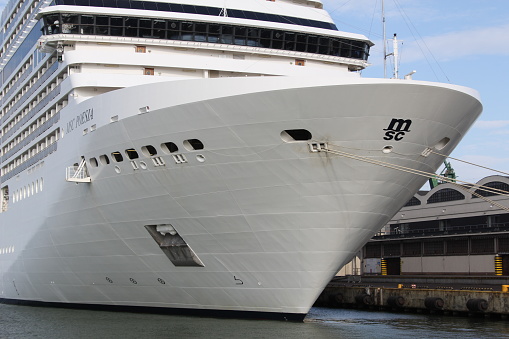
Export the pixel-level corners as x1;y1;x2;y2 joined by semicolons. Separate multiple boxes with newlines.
338;175;509;276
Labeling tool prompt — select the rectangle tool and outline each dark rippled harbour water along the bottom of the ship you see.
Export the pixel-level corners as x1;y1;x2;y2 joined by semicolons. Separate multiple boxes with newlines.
0;304;509;339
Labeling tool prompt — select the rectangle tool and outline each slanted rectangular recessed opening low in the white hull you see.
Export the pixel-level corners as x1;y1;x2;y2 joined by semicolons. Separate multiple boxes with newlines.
145;224;205;267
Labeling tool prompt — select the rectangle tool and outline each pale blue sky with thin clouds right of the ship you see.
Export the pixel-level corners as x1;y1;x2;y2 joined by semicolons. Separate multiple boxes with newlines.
322;0;509;188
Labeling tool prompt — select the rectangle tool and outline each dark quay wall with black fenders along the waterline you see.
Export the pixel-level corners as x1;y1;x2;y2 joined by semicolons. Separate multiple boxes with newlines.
315;276;509;319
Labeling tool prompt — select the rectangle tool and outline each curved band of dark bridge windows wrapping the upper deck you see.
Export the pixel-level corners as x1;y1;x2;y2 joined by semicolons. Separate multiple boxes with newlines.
43;13;369;60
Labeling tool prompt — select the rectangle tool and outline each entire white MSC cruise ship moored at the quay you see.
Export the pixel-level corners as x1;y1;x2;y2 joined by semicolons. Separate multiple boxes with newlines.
0;0;482;321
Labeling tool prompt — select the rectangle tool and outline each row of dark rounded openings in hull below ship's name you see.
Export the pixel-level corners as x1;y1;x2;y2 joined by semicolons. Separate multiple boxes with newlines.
89;139;204;167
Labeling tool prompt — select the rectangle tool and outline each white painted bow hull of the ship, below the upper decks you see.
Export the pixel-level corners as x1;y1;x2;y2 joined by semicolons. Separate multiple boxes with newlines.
0;76;481;318
